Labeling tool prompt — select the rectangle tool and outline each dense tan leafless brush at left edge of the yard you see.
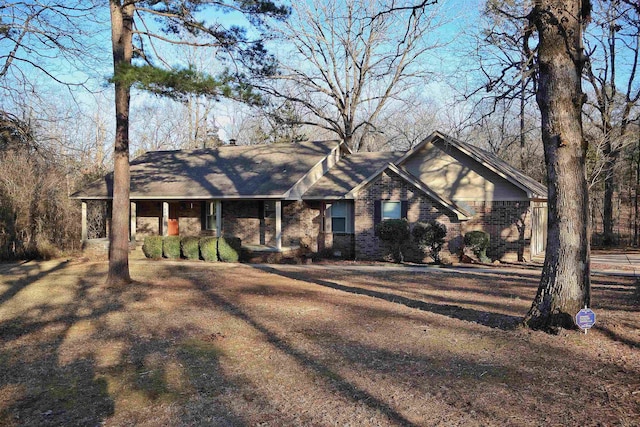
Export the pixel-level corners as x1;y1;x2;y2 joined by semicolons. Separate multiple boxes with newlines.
0;110;84;259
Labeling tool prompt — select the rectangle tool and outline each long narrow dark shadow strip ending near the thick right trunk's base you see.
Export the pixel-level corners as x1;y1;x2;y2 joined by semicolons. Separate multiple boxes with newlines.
250;266;522;331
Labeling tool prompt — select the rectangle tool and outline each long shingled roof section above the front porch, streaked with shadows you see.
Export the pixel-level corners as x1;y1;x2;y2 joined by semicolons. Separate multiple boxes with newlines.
72;141;339;199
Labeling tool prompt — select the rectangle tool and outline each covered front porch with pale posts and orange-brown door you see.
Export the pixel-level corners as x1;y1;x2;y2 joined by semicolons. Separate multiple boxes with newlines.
82;200;320;253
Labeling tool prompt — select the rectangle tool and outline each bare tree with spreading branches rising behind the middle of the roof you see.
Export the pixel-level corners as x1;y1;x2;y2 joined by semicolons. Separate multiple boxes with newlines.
263;0;443;151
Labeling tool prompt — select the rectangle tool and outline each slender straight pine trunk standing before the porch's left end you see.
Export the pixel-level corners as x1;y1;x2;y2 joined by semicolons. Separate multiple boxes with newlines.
107;0;134;286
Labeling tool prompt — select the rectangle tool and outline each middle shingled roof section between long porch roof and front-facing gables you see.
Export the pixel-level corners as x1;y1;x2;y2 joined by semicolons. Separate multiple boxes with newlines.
303;151;404;200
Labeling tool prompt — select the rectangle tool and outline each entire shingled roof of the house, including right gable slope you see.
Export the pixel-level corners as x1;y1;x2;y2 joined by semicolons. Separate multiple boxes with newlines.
71;132;547;204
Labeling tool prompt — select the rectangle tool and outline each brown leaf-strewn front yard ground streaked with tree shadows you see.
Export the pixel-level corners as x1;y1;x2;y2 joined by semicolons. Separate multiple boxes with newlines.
0;260;640;426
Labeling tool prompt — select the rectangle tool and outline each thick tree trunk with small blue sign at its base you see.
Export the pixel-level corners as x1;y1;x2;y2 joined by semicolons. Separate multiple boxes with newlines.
524;0;591;331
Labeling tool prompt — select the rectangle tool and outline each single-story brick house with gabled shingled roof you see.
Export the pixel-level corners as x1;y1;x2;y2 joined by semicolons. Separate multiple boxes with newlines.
72;132;547;259
